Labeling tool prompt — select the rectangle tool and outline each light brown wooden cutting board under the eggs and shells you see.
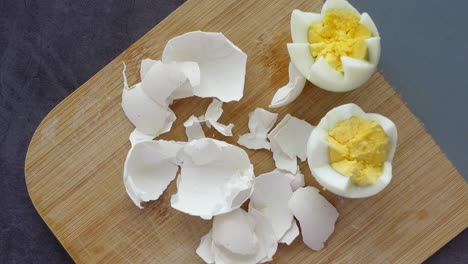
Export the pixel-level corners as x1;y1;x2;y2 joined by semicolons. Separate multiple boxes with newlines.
26;0;468;264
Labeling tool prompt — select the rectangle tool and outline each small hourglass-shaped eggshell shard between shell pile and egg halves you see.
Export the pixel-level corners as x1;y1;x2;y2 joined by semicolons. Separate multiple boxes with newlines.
237;108;278;150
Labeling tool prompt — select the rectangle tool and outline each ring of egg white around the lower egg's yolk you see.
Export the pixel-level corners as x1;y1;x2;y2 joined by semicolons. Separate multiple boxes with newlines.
307;104;398;198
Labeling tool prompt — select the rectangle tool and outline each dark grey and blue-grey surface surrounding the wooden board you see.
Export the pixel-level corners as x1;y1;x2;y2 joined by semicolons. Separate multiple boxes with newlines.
0;0;468;263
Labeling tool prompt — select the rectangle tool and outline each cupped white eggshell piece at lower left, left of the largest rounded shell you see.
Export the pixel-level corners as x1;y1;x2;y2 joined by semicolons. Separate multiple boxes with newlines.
123;140;184;208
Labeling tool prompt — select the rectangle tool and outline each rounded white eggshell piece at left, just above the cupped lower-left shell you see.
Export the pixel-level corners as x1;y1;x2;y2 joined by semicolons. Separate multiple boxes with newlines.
122;84;176;138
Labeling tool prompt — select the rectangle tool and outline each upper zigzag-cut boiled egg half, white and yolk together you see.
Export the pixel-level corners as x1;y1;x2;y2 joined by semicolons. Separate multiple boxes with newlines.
288;0;380;92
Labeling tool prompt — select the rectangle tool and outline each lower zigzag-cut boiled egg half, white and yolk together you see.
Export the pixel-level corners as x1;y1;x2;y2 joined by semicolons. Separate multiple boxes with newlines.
307;104;397;198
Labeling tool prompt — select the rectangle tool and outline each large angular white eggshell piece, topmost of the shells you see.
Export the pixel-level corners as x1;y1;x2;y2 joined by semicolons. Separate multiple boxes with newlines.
162;31;247;102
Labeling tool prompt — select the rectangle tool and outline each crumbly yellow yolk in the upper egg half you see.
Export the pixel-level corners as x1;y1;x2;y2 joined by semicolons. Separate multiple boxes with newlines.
308;9;372;72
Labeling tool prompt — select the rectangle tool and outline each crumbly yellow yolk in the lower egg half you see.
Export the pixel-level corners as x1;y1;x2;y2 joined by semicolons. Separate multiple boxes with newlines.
327;116;390;186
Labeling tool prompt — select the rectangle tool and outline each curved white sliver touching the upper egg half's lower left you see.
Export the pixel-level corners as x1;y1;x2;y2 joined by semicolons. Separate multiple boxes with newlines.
269;62;306;108
